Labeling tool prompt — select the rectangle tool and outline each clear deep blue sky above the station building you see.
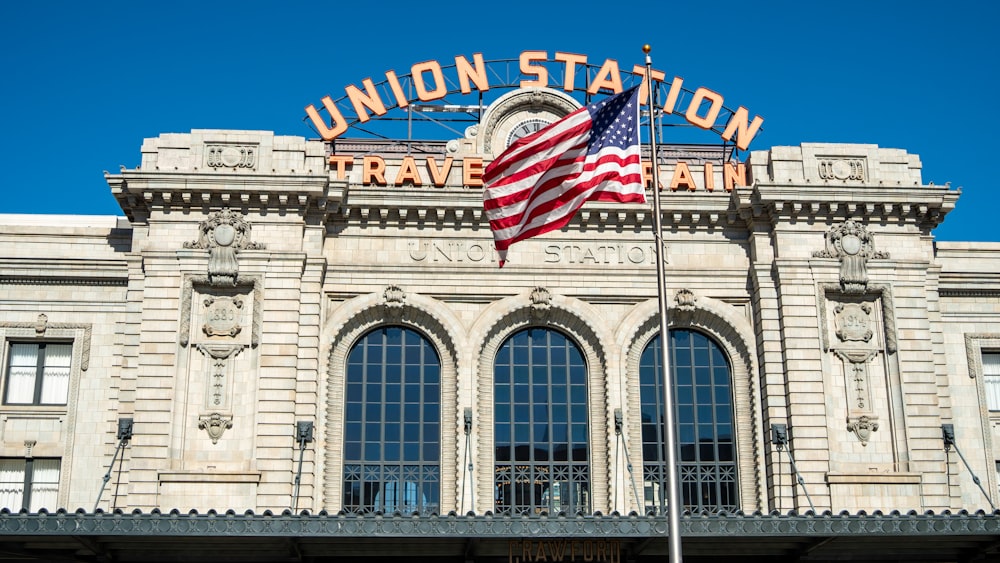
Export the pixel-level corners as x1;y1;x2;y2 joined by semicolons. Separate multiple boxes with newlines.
0;0;1000;241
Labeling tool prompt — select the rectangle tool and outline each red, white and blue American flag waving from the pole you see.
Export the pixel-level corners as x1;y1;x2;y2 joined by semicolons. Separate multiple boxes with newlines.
483;87;646;268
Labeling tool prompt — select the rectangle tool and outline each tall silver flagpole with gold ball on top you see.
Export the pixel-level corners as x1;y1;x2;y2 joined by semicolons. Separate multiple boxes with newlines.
642;45;684;563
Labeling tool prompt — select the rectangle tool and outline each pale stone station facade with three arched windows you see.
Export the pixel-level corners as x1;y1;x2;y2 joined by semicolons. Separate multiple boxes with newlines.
0;87;1000;560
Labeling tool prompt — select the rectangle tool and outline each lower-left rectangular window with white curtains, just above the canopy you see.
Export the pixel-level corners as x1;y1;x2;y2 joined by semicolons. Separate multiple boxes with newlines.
0;459;59;512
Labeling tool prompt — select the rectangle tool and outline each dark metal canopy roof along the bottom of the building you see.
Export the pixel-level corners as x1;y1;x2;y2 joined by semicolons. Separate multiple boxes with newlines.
0;510;1000;563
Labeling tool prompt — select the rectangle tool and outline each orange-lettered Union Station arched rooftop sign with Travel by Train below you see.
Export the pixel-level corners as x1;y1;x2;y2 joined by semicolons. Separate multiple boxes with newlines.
305;51;764;192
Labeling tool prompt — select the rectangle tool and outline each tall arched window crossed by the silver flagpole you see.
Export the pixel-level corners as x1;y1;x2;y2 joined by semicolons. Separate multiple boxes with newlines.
639;329;739;512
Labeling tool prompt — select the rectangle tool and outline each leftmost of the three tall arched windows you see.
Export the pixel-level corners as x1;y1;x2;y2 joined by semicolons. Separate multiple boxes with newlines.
344;326;441;514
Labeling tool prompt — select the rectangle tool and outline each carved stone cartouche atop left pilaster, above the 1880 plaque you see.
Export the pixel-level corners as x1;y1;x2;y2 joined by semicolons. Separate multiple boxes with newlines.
184;208;264;286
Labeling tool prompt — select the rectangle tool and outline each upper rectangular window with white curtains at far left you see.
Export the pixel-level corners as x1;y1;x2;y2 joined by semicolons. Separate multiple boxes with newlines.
3;342;73;405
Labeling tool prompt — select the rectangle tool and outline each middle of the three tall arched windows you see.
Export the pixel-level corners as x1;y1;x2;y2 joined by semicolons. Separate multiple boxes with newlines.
493;328;590;514
